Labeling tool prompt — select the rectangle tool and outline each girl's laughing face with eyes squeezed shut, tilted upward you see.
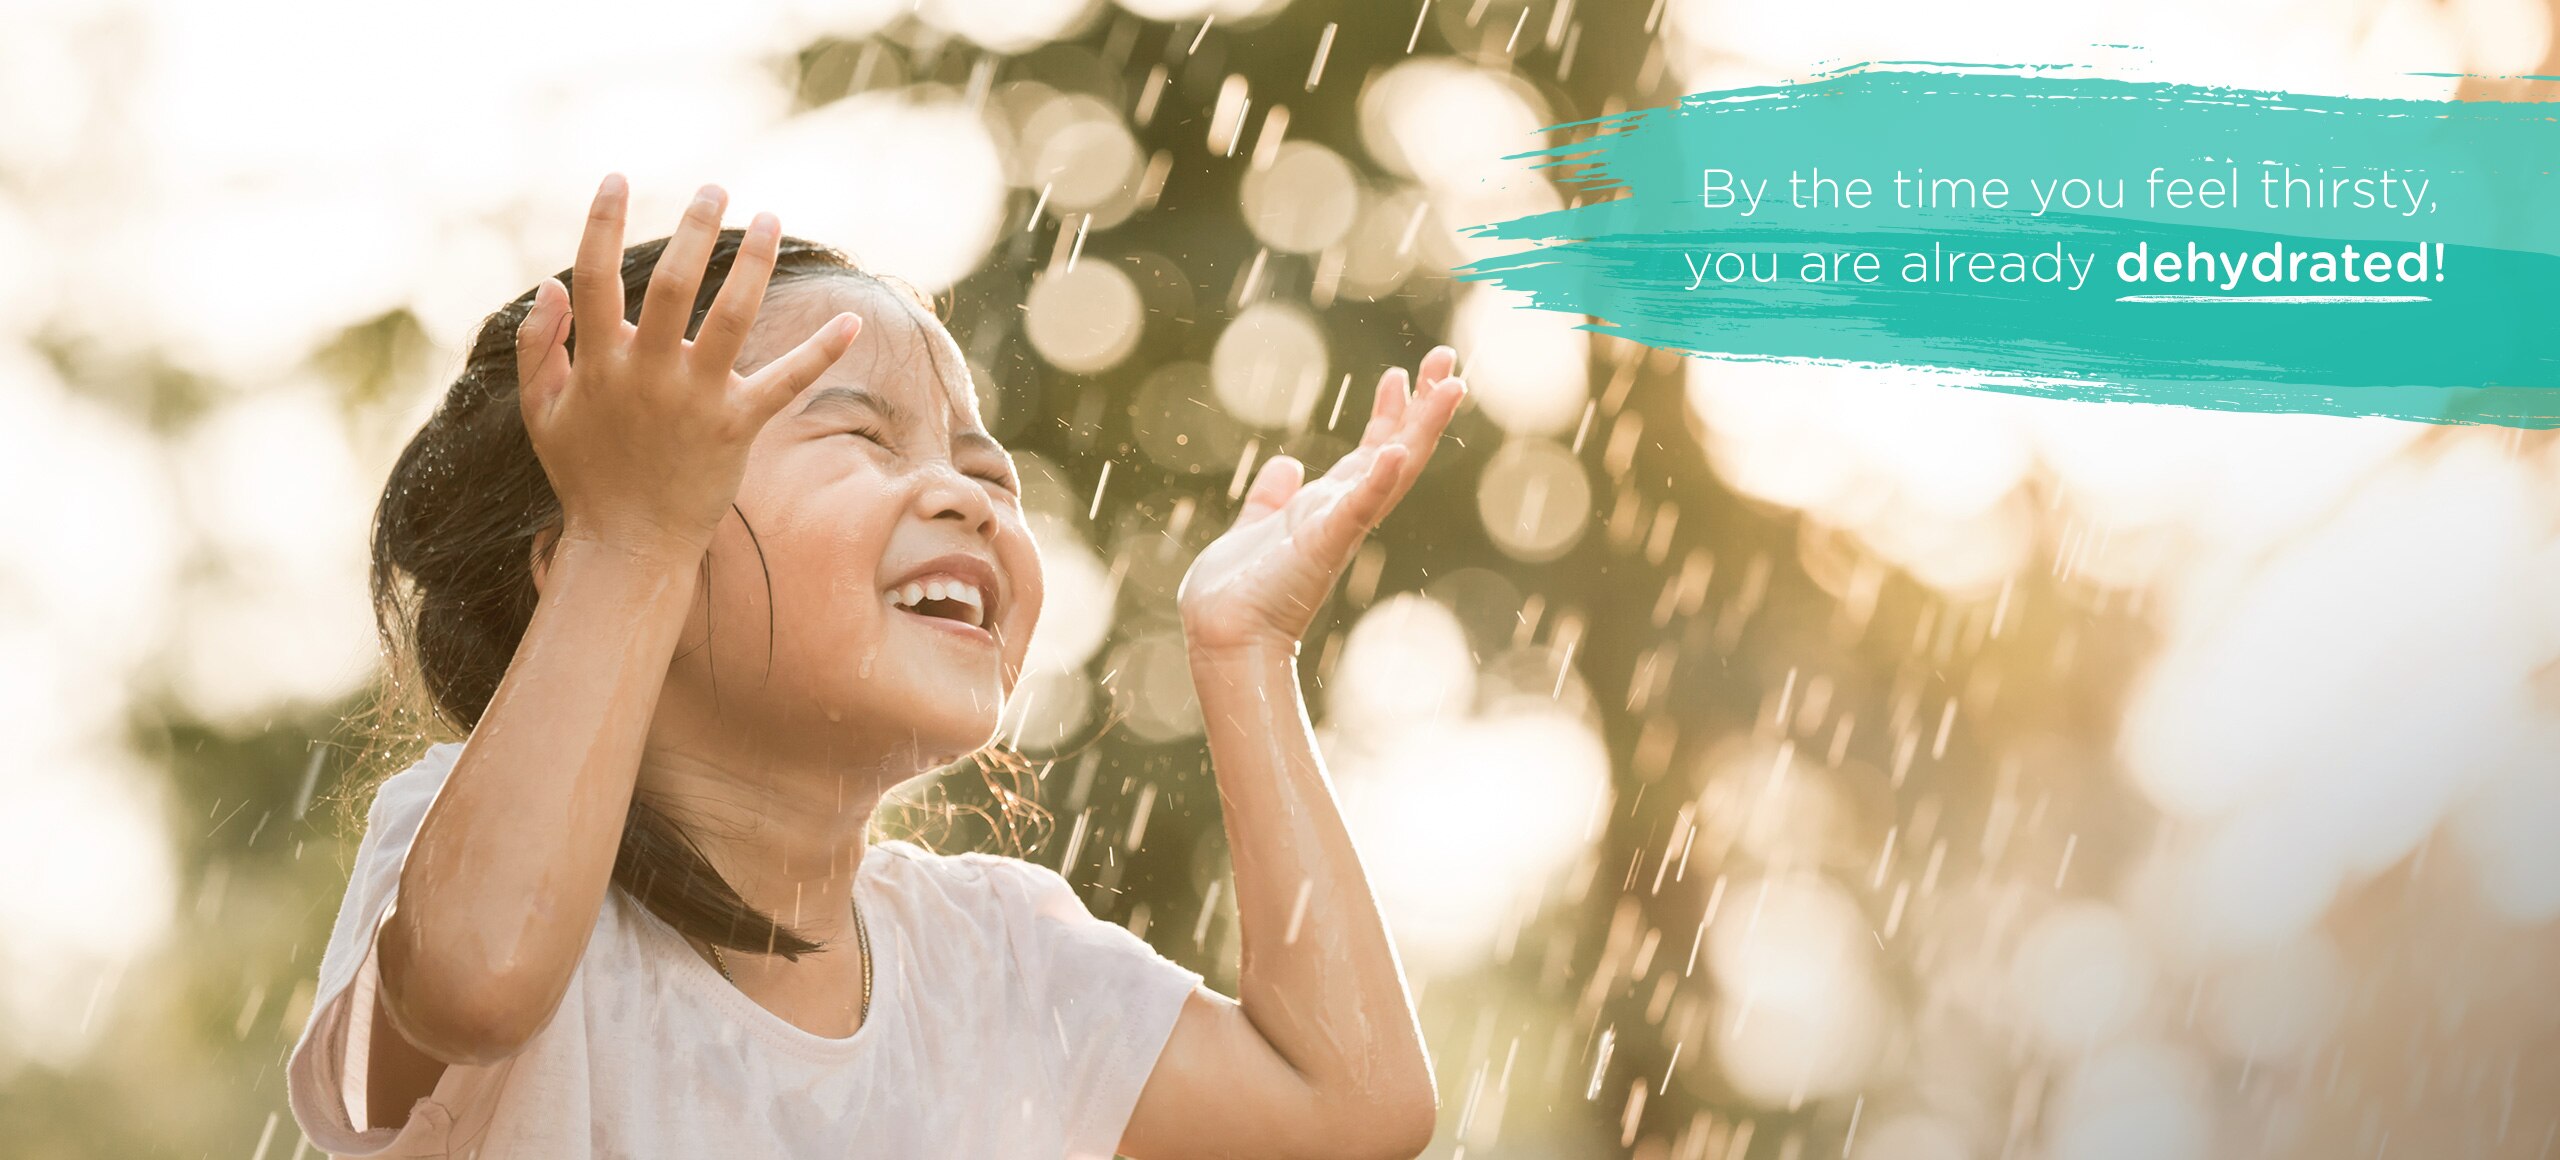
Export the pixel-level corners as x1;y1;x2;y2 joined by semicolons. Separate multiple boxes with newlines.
663;277;1042;789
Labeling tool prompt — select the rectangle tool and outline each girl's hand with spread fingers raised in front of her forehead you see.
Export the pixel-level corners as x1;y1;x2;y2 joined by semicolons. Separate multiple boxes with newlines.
517;174;863;563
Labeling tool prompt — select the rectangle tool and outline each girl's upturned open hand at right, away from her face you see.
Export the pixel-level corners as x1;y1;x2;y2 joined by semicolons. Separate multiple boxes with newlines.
1175;346;1467;650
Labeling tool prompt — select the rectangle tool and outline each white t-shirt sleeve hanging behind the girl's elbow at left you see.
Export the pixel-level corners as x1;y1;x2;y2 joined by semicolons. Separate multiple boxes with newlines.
284;743;476;1157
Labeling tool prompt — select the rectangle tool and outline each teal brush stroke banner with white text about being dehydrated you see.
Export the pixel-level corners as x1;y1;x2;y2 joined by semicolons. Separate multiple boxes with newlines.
1457;64;2560;428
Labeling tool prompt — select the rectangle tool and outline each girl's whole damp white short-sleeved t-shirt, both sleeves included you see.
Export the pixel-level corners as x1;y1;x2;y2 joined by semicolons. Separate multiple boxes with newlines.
287;743;1201;1160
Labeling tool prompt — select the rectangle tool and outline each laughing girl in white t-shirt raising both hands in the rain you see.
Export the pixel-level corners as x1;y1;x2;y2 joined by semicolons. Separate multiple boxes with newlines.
289;174;1464;1160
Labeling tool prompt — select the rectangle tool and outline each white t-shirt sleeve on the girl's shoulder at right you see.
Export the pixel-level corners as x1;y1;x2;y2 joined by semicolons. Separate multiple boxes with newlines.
978;855;1201;1160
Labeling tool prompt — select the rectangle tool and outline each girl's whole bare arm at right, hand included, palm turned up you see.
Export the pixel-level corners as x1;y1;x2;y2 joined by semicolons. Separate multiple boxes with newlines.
1121;348;1464;1157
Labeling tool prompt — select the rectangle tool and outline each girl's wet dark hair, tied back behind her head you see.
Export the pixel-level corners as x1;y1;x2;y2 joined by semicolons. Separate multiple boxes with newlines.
371;228;1037;958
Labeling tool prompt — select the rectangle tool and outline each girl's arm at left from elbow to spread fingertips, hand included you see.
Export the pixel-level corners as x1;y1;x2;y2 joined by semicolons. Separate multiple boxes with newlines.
374;177;855;1075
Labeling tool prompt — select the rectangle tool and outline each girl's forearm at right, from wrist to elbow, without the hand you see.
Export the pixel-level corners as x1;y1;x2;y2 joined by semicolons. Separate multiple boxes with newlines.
1190;640;1434;1124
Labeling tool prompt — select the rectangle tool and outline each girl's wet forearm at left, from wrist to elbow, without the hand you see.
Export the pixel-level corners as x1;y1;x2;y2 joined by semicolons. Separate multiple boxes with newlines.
379;535;699;1063
